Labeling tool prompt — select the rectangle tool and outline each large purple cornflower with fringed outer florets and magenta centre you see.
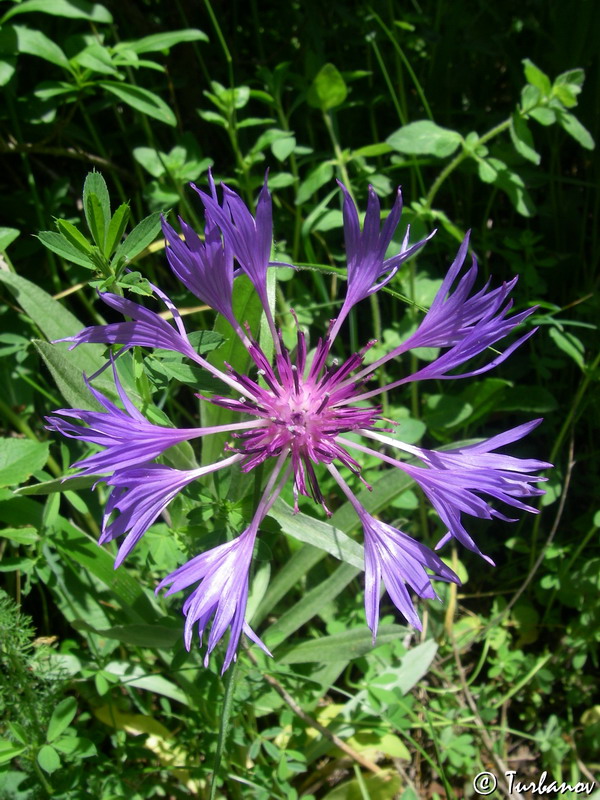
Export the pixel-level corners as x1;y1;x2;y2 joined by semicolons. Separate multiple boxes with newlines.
48;176;551;669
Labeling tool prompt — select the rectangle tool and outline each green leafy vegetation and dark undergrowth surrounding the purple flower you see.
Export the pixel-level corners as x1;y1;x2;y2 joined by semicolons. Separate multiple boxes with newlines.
0;0;600;800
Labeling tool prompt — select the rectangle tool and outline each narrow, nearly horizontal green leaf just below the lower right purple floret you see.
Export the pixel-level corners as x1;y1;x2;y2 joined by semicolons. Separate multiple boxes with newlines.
277;625;407;664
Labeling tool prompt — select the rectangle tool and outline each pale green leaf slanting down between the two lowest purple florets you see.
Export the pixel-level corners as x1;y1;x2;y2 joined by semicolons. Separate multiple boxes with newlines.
269;499;364;570
